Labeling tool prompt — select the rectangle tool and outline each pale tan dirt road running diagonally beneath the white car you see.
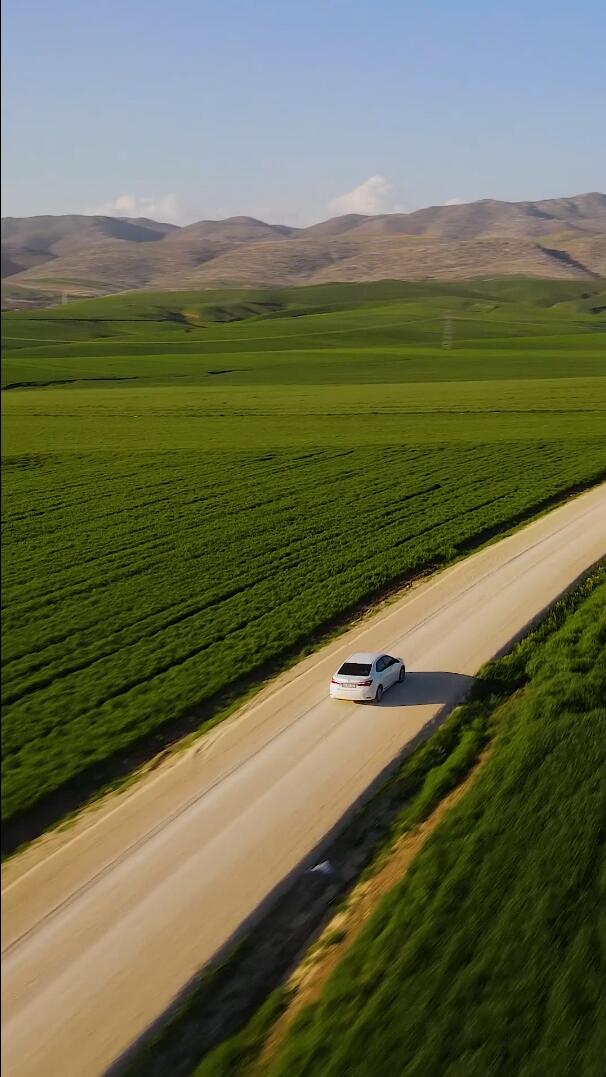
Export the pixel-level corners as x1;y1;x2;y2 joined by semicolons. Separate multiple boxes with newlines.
2;485;606;1077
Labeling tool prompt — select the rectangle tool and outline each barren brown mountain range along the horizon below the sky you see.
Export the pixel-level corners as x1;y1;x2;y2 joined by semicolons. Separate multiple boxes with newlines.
2;194;606;305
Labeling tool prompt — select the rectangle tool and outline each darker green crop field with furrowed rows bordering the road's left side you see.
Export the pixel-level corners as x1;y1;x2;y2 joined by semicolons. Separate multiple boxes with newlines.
2;440;604;817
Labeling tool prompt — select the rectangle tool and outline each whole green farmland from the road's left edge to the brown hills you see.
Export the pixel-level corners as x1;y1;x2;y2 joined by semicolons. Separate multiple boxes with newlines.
2;280;606;821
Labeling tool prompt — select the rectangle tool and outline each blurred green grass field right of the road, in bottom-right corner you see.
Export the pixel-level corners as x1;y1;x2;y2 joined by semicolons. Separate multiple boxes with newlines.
264;573;606;1077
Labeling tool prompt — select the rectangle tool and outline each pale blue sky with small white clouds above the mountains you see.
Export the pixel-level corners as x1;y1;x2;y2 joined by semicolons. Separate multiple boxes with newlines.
2;0;606;224
